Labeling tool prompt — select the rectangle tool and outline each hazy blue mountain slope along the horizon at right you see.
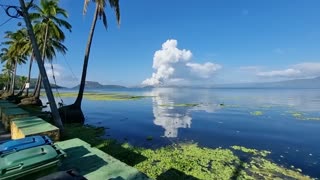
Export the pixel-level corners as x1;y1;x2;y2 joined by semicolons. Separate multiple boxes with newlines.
212;76;320;89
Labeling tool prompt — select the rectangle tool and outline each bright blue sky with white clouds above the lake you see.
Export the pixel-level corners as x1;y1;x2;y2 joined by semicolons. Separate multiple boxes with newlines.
0;0;320;87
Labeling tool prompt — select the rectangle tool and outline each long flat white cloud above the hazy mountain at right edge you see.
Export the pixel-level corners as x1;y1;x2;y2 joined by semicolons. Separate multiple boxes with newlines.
256;62;320;78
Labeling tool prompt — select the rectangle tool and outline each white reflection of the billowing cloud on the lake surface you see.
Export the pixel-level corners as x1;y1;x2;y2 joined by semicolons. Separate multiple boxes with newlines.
149;88;220;138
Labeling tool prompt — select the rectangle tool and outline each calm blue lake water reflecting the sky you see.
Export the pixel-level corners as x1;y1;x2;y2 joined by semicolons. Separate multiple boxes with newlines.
53;88;320;177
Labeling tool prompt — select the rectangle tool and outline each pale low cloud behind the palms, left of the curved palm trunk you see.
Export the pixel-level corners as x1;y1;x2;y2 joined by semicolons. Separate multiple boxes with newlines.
44;63;79;87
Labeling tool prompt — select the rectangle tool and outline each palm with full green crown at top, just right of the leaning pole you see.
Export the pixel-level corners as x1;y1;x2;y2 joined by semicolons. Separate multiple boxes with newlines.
29;0;71;99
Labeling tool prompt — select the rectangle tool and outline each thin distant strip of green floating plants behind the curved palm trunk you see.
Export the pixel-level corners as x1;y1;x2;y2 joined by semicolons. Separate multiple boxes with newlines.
59;93;148;101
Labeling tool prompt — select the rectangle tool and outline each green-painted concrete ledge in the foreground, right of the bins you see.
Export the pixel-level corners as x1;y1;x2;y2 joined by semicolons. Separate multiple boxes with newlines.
55;138;149;180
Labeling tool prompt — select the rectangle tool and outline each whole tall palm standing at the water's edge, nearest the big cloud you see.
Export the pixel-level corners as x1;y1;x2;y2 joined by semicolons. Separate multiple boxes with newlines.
59;0;120;123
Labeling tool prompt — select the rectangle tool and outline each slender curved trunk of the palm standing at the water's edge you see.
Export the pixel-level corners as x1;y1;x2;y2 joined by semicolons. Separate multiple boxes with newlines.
74;3;99;108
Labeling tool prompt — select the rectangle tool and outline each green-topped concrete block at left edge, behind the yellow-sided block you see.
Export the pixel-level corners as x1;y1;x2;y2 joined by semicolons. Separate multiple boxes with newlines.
1;108;30;131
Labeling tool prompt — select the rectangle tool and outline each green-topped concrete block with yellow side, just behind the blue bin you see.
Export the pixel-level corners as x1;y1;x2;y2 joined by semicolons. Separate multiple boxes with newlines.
11;116;60;141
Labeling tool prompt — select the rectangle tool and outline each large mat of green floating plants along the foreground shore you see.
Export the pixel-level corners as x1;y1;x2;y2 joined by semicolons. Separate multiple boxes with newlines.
64;125;311;179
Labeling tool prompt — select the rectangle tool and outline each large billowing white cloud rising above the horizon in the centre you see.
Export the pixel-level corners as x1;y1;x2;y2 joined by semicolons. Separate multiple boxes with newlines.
142;39;221;85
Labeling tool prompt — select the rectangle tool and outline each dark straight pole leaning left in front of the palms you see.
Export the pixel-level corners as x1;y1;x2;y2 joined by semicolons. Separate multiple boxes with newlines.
19;0;63;134
